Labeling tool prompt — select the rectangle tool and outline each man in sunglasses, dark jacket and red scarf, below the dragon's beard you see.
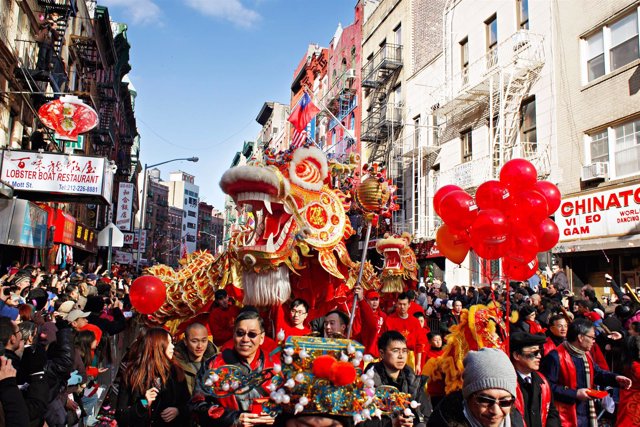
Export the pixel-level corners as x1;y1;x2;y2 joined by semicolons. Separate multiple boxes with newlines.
189;310;275;427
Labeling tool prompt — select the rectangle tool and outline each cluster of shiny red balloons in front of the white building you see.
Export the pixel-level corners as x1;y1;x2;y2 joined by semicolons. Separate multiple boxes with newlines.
433;159;561;280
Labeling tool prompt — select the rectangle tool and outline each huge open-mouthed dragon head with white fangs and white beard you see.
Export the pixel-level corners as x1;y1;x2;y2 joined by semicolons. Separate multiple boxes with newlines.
220;147;353;306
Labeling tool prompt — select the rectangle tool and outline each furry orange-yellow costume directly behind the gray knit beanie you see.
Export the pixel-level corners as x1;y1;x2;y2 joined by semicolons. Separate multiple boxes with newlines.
422;303;508;395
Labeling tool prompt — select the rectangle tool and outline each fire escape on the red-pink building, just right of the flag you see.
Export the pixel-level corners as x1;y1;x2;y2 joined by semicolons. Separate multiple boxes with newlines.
325;68;358;159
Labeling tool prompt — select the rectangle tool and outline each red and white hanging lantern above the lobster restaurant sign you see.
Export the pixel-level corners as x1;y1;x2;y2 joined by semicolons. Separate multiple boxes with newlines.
38;95;98;141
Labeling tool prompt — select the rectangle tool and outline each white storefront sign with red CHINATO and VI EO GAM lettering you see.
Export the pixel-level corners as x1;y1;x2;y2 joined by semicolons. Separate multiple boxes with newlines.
556;184;640;242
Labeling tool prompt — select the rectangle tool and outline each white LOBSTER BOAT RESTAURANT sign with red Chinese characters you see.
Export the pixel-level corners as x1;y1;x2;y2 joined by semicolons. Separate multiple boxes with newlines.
0;150;113;204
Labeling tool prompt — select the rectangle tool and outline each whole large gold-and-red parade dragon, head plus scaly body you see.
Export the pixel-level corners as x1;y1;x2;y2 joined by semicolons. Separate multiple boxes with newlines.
147;147;380;322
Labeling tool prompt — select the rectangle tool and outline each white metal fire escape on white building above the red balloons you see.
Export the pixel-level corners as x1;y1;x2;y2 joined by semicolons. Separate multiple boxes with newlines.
432;30;550;188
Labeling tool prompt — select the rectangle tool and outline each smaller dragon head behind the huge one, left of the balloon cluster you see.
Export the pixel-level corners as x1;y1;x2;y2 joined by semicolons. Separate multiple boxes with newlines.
376;233;418;293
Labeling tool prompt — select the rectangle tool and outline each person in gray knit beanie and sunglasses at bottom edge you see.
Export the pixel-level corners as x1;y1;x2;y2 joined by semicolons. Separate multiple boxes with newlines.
427;348;524;427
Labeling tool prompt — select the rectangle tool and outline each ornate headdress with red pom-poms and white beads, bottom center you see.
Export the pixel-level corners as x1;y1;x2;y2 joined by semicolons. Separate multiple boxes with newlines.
201;337;419;424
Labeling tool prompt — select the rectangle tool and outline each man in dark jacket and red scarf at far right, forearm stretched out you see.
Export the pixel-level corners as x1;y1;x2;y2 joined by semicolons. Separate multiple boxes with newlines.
540;319;631;427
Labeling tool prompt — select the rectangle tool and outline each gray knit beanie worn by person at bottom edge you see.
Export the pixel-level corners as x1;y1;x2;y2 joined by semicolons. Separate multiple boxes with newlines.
462;348;518;399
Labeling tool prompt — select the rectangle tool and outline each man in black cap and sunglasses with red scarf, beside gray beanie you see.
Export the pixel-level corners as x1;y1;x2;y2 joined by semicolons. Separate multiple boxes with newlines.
509;332;560;427
